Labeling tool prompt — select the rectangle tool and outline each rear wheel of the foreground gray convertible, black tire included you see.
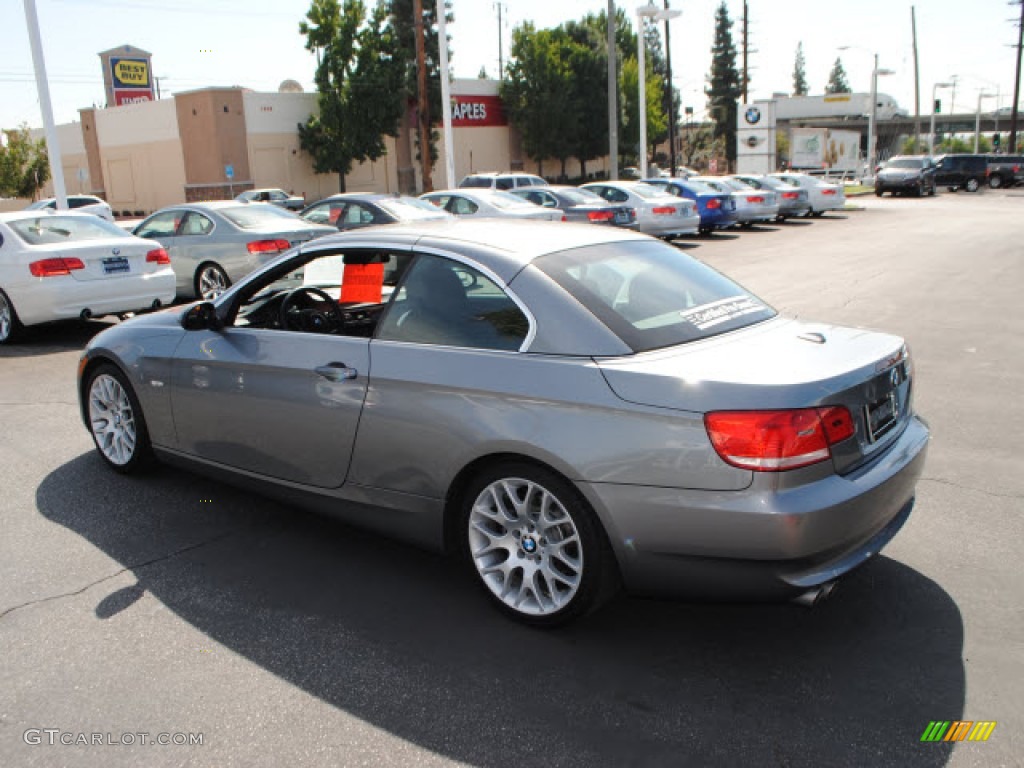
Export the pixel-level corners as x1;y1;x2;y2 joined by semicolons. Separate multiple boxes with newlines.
462;462;616;627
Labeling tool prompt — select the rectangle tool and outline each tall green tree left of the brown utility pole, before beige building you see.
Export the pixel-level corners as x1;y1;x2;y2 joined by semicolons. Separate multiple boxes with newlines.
299;0;406;191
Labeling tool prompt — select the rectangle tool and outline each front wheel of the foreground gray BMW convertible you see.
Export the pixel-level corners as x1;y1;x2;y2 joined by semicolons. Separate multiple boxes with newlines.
85;364;153;474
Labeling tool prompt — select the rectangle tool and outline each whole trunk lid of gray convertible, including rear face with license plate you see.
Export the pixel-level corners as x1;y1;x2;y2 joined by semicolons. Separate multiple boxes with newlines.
596;317;911;473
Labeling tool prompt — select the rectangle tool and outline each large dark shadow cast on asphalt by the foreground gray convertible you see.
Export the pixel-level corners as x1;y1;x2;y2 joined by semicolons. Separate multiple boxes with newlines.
37;454;965;768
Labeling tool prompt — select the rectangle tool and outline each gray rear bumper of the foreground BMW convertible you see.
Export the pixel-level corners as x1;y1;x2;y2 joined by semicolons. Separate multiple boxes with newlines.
579;417;929;598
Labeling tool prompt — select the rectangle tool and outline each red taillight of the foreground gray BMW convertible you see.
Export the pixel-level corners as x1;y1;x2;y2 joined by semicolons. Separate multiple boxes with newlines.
705;406;854;472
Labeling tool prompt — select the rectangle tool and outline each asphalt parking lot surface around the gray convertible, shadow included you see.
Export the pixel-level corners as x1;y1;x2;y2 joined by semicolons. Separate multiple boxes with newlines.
0;190;1024;767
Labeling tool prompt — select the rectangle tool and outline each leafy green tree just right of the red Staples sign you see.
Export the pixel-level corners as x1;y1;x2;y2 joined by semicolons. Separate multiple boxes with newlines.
499;22;575;175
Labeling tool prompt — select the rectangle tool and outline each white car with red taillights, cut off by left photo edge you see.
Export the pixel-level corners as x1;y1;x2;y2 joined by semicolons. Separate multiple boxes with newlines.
0;210;174;344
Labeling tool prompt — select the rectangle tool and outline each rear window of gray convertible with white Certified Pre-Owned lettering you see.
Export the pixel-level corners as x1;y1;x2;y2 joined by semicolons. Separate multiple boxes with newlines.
534;241;775;352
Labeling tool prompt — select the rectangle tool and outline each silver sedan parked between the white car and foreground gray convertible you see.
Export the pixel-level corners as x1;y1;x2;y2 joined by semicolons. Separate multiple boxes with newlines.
133;201;338;299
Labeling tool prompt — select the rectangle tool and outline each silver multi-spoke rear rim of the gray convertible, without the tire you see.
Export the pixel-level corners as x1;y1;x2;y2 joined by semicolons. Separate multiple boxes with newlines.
468;477;585;616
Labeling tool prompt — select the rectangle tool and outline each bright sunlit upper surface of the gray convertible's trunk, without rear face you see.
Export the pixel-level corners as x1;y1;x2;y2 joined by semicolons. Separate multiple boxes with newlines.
596;317;903;413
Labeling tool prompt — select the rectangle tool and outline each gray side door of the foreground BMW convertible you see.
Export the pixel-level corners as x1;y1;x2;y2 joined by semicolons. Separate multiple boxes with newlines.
171;244;399;488
